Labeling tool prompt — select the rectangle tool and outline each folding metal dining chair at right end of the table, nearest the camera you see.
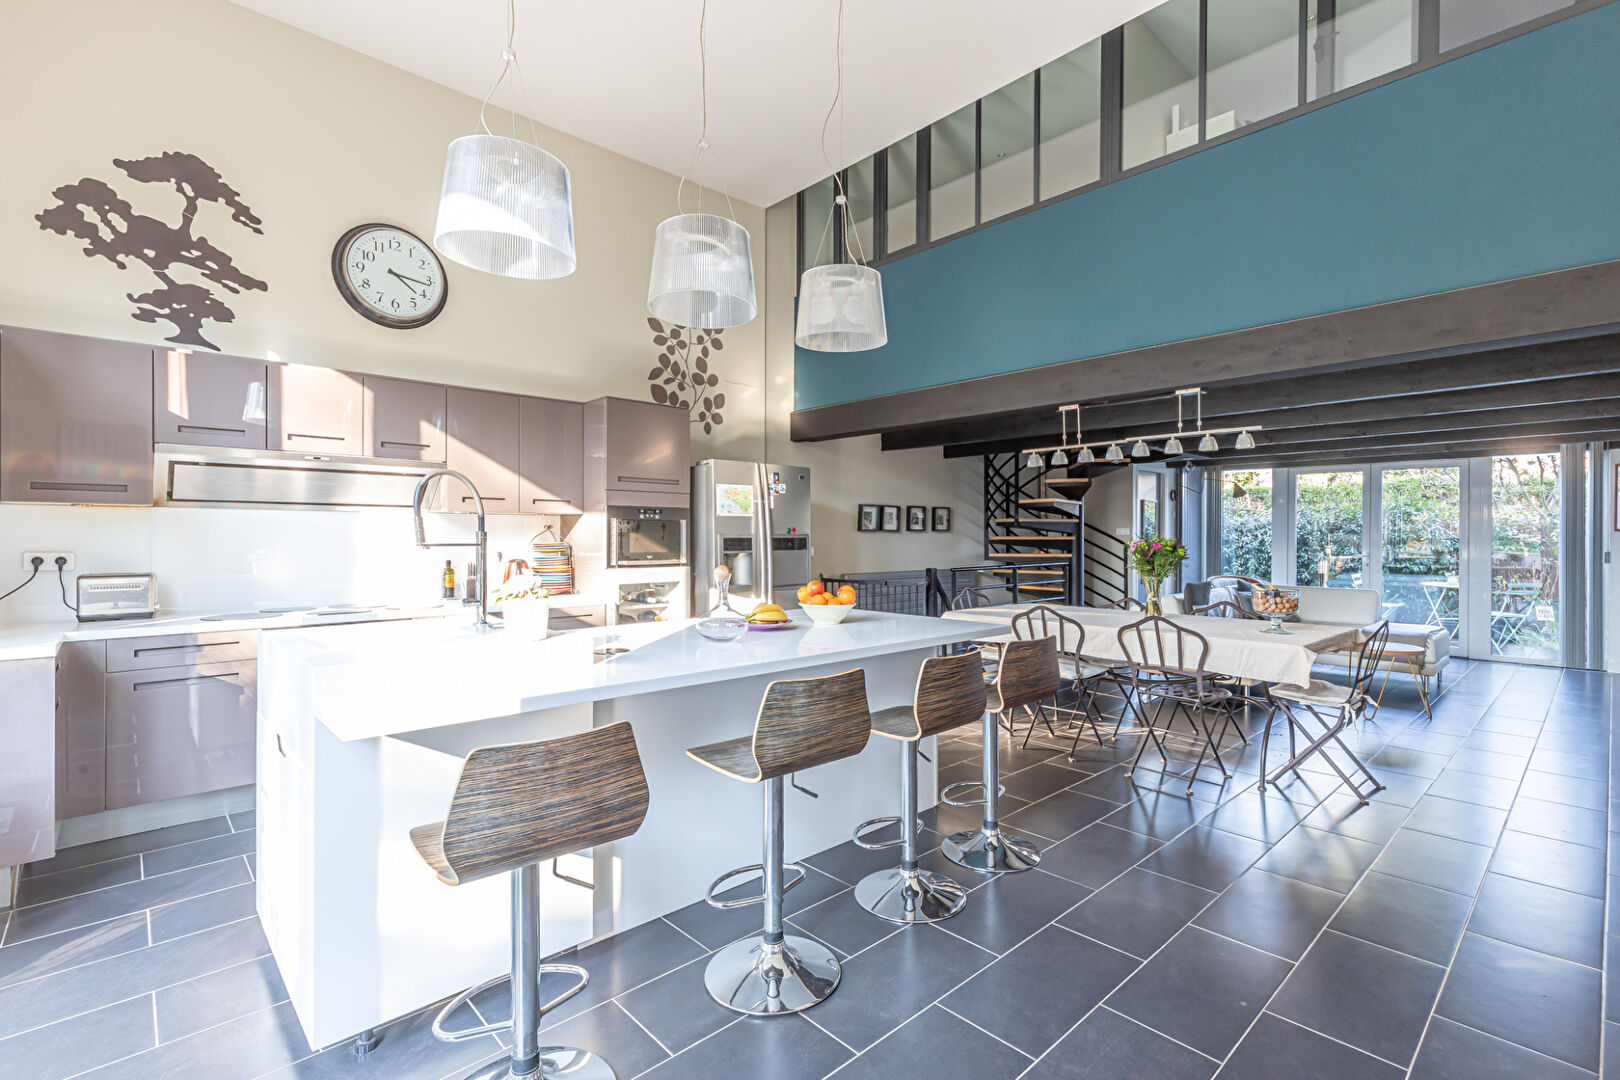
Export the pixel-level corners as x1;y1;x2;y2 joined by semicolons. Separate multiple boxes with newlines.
1260;620;1390;806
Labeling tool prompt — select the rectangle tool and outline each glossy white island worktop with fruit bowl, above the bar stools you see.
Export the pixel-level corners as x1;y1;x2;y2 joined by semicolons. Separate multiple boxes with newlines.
261;612;983;742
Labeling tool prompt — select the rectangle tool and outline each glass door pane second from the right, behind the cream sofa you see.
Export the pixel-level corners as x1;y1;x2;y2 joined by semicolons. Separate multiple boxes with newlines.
1379;465;1468;649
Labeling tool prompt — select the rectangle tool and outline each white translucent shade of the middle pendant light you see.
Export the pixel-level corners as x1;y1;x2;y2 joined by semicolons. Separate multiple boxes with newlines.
646;214;758;330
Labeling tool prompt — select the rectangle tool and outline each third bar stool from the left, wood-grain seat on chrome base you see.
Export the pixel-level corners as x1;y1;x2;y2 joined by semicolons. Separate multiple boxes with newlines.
854;653;985;923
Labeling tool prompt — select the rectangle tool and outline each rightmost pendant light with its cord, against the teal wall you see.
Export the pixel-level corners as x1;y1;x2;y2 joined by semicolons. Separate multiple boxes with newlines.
794;0;889;353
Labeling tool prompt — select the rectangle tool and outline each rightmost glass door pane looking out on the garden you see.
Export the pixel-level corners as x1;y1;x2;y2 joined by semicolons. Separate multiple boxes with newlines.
1473;453;1563;664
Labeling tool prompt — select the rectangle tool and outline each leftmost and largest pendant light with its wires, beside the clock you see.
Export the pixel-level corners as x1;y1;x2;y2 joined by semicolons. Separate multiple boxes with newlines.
433;0;575;280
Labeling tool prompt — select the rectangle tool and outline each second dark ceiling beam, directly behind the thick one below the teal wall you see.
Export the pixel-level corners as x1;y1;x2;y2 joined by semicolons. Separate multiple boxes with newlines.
883;335;1620;450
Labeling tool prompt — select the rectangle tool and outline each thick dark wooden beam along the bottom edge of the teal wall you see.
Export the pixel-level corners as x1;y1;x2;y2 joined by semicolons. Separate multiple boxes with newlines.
791;261;1620;442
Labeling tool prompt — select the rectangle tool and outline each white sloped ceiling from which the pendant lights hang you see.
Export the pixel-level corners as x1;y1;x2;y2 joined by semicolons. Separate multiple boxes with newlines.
235;0;1162;206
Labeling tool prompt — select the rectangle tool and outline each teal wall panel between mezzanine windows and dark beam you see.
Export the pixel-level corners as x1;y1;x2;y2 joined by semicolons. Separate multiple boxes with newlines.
794;3;1620;408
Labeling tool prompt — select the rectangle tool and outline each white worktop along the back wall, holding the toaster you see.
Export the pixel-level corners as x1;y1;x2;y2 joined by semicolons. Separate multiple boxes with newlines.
0;596;588;661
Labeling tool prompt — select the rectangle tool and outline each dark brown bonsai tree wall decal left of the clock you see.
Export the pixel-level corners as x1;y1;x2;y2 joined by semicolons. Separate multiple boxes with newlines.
34;151;269;351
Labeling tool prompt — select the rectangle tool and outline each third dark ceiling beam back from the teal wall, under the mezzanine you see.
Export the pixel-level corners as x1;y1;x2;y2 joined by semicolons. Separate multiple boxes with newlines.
946;388;1620;457
